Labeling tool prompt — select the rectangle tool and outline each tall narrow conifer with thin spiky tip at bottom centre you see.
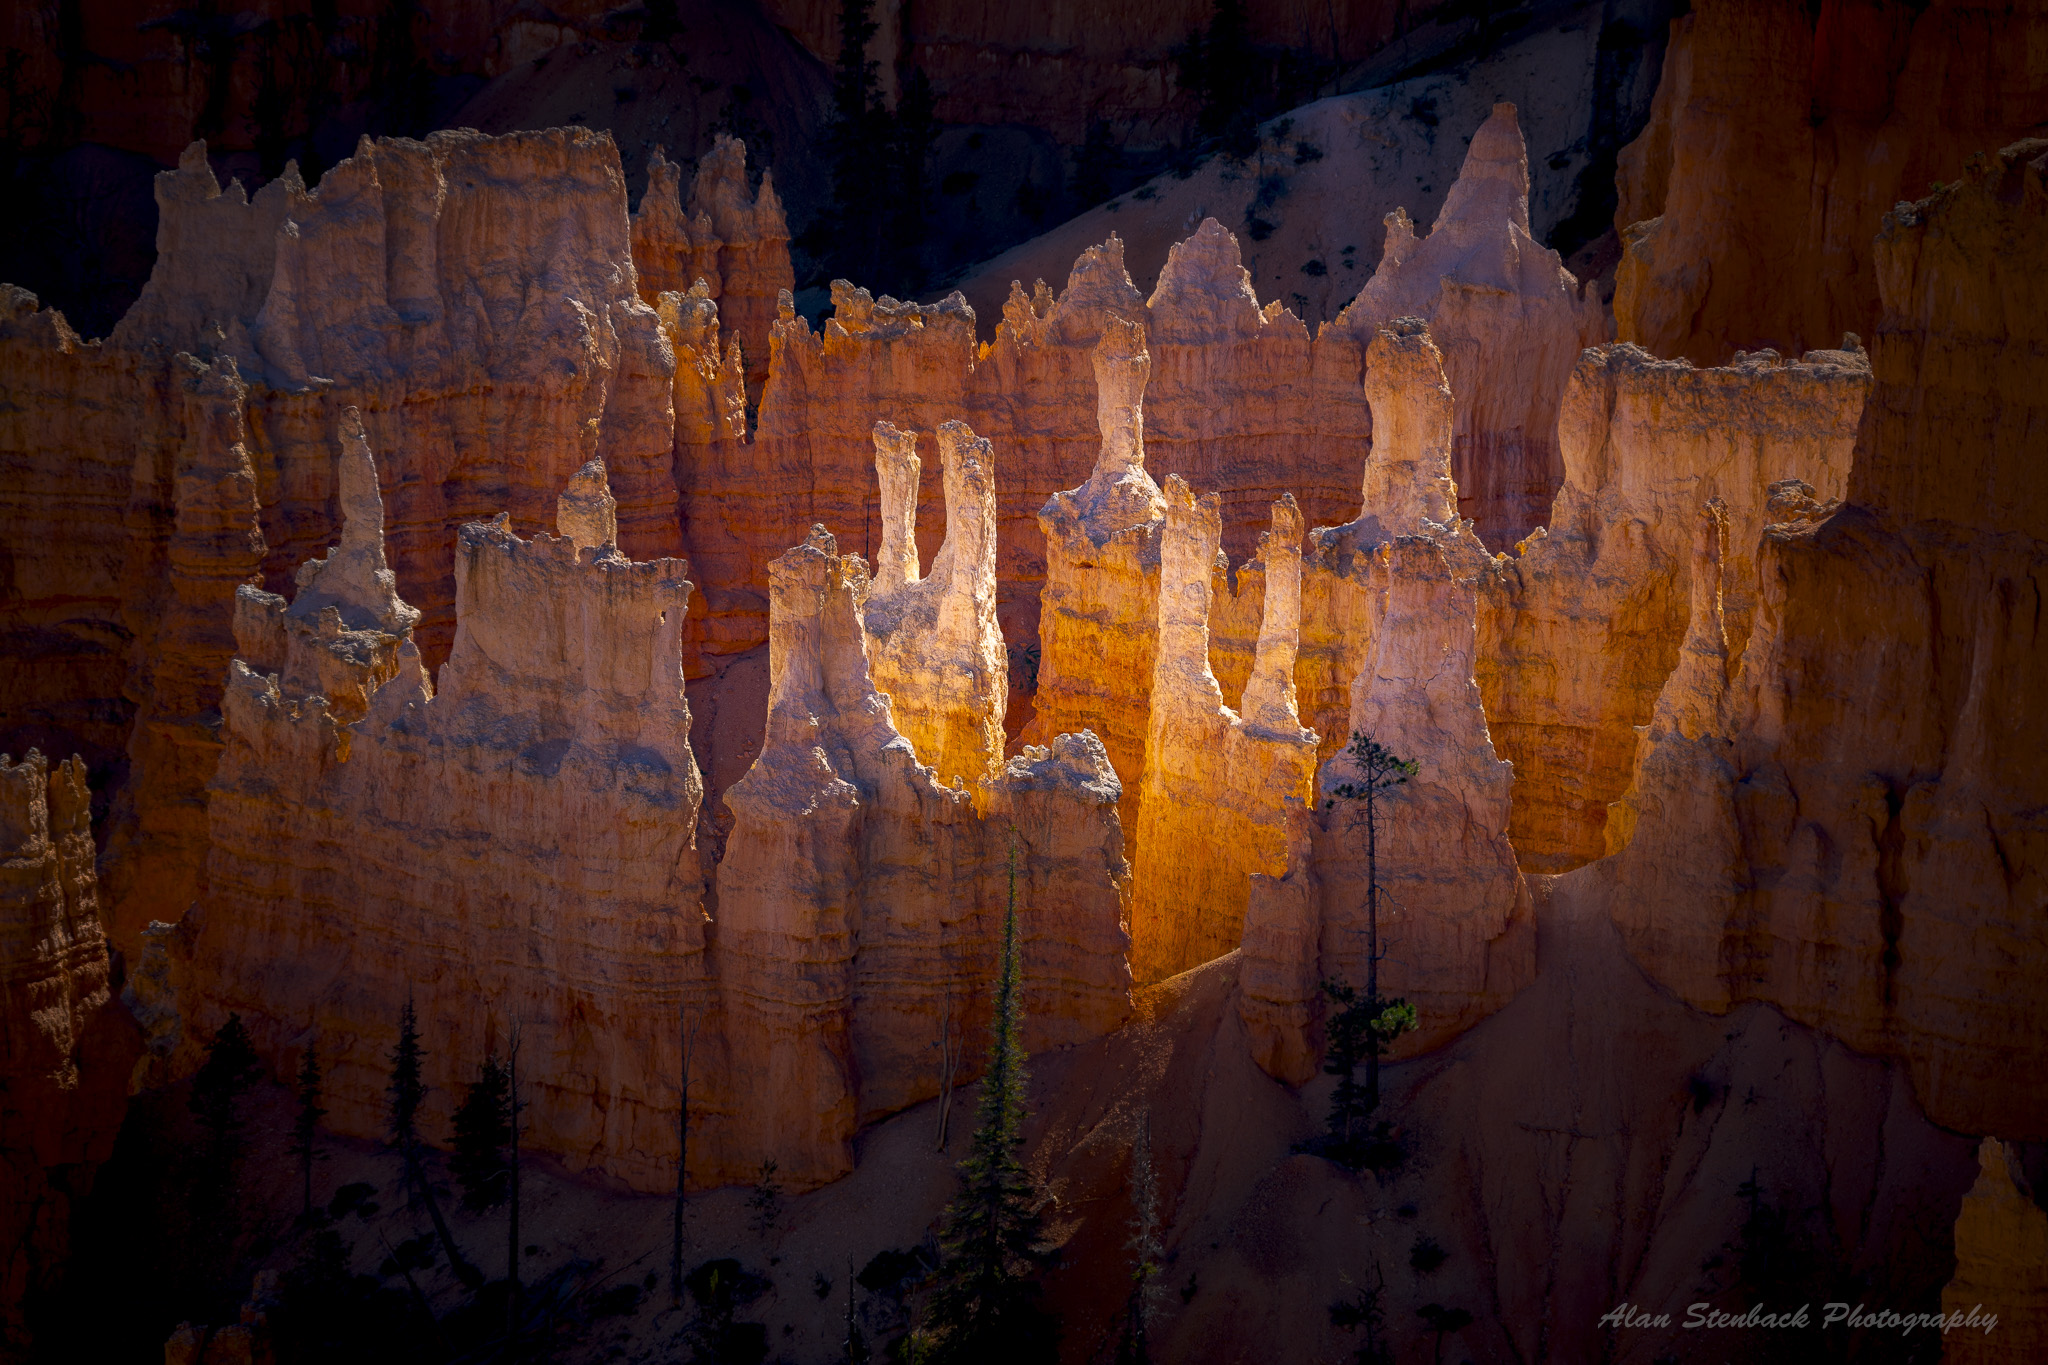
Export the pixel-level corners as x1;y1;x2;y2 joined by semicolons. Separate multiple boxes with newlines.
930;843;1059;1365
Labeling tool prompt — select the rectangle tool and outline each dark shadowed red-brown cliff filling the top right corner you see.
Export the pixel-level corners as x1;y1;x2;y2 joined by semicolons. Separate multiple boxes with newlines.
1614;0;2048;364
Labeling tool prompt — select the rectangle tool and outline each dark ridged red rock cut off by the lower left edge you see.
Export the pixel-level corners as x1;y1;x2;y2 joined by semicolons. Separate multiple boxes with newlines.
0;749;135;1357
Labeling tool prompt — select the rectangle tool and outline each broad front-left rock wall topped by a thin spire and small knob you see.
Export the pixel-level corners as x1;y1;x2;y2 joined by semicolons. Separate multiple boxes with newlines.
182;431;711;1185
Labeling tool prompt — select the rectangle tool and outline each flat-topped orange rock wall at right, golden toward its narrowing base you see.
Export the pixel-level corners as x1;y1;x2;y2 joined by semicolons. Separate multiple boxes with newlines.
1479;342;1870;872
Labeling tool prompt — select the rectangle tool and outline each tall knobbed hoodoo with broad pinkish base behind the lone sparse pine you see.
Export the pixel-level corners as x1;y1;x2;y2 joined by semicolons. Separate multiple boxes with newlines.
1239;319;1536;1085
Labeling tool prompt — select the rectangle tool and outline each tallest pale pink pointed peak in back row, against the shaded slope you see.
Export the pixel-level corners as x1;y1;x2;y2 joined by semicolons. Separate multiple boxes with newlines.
1333;104;1606;548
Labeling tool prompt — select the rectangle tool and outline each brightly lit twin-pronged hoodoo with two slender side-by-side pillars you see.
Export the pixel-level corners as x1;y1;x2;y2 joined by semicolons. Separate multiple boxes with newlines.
860;422;1010;788
